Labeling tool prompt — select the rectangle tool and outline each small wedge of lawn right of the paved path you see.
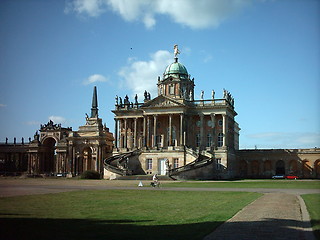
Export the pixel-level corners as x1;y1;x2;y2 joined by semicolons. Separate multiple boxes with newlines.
302;194;320;239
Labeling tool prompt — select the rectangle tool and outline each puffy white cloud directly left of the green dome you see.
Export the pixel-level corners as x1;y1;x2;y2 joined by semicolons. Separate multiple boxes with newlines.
118;50;173;101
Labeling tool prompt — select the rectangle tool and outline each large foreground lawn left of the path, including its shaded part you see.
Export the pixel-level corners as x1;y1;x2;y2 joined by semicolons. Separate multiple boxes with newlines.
0;190;261;240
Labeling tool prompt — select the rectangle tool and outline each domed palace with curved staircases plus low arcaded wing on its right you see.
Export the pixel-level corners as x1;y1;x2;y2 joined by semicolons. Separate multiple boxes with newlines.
104;49;320;179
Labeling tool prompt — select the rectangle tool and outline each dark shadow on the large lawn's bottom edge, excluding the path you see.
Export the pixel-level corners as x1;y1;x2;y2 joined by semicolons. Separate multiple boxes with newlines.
0;218;221;240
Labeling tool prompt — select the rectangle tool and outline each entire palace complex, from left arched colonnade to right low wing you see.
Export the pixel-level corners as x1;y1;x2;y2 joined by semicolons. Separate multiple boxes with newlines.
0;45;320;179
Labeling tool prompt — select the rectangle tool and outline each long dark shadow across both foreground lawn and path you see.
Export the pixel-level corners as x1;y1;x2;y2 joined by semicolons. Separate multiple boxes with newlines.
0;218;316;240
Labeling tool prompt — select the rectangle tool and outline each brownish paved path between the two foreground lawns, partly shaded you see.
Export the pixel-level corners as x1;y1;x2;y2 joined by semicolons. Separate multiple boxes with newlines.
204;193;314;240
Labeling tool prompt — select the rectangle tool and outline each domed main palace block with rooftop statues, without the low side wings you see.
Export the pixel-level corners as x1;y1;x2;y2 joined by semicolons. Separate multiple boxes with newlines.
104;48;240;178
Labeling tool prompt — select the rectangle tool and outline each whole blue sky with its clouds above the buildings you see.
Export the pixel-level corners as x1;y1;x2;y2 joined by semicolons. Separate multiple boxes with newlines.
0;0;320;148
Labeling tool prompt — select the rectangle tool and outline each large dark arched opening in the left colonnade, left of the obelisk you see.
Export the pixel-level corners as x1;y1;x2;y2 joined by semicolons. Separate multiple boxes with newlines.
39;137;57;174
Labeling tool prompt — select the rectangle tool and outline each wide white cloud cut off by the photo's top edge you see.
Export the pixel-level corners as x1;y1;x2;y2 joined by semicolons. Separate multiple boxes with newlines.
65;0;252;29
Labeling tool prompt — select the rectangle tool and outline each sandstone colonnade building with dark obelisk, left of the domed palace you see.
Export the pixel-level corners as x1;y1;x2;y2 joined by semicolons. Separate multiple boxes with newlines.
0;87;114;176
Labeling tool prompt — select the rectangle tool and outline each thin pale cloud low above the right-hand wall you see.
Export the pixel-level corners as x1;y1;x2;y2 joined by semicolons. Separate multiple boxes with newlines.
245;132;320;148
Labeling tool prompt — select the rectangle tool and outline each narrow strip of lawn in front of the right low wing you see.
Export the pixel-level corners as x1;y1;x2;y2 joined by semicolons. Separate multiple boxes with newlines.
162;180;320;189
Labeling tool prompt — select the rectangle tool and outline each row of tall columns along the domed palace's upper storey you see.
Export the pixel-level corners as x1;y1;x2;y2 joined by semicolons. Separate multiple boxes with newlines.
114;113;227;149
